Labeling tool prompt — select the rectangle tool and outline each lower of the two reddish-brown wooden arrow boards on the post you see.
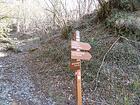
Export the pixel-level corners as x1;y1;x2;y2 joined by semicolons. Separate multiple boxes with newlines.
71;51;92;60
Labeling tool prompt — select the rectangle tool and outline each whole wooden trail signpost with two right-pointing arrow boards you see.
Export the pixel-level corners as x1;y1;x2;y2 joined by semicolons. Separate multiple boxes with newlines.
70;31;92;105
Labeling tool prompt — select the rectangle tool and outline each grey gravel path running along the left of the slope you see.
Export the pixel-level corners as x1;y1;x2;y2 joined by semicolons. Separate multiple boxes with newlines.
0;32;55;105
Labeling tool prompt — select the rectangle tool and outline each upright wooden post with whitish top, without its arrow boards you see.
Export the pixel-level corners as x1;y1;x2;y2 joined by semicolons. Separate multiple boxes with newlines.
74;31;82;105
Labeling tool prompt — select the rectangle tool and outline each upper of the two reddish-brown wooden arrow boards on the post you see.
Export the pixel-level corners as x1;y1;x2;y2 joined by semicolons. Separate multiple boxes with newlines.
71;41;91;50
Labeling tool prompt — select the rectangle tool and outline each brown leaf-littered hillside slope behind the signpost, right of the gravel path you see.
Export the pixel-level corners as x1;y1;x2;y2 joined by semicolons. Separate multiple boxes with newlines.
23;9;140;105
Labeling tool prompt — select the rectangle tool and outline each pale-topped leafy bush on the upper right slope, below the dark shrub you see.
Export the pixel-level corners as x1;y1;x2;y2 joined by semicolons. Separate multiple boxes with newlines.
105;10;140;40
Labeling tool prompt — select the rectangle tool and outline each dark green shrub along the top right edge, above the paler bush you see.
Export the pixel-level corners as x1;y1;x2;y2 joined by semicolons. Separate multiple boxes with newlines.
96;0;137;22
